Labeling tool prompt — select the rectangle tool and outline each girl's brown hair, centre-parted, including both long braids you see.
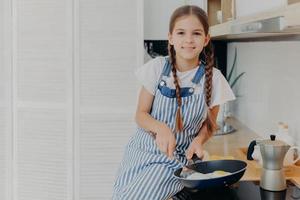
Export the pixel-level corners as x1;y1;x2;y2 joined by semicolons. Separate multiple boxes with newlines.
168;5;214;132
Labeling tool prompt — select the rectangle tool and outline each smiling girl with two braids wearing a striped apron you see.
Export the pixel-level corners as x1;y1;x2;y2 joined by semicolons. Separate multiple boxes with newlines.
113;6;235;200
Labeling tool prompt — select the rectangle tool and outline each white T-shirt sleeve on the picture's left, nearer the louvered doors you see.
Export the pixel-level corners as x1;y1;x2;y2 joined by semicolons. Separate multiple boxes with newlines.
134;57;165;95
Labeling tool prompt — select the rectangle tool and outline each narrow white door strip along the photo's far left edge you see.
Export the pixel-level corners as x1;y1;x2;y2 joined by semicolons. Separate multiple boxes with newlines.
0;0;12;200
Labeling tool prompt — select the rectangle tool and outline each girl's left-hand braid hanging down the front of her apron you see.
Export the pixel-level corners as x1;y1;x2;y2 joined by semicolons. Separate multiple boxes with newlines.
168;44;183;131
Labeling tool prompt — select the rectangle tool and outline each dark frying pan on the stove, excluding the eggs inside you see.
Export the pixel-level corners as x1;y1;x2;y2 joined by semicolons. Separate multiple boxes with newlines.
174;160;247;189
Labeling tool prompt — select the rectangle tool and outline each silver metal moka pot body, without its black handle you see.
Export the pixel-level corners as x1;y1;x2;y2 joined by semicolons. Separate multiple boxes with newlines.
258;135;290;191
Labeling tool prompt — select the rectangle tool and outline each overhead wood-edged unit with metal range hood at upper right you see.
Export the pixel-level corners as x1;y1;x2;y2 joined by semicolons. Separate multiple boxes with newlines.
210;3;300;40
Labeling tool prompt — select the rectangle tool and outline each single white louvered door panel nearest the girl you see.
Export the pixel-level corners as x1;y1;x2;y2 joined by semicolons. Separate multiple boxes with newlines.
75;0;143;200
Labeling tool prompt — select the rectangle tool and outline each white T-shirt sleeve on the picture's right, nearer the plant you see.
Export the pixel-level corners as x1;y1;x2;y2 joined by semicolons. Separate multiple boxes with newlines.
210;68;235;108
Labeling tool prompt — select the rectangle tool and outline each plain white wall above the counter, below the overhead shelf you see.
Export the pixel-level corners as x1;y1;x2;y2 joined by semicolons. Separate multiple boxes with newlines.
227;37;300;145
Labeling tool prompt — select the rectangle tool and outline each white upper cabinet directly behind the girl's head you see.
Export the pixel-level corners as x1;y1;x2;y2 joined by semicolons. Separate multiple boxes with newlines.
144;0;207;40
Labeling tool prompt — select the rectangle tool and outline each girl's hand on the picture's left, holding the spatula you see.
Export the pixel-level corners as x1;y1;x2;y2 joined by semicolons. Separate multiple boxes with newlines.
155;123;176;159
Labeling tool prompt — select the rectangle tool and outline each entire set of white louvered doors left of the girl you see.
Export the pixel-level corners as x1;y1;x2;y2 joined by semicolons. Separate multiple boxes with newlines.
0;0;143;200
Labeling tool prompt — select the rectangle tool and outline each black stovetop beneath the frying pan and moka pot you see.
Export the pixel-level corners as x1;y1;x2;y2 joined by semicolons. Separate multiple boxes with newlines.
178;181;292;200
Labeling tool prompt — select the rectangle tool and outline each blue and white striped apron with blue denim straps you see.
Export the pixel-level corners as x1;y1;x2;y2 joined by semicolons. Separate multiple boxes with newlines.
113;57;207;200
